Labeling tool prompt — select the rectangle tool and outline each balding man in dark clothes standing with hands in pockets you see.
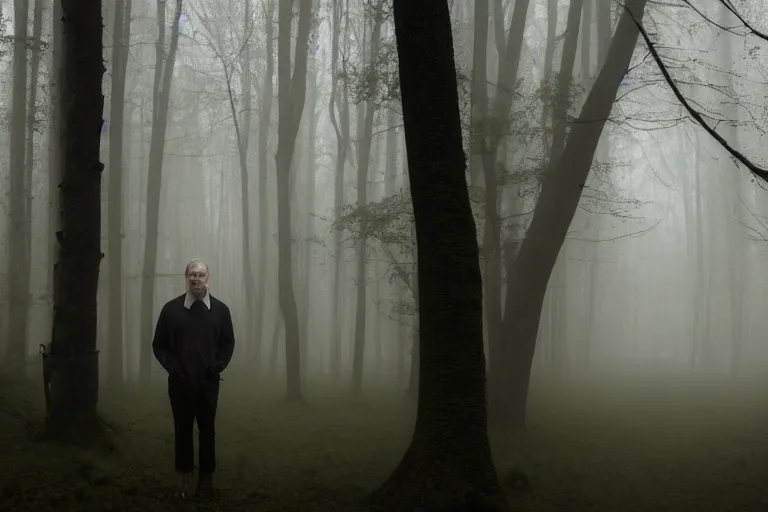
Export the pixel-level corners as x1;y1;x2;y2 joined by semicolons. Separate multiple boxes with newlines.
152;260;235;497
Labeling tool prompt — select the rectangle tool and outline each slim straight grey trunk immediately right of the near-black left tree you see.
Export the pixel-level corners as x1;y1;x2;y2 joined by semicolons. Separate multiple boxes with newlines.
107;0;132;384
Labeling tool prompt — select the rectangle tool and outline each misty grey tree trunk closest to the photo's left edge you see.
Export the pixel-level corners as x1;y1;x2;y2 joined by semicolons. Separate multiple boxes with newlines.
7;0;31;364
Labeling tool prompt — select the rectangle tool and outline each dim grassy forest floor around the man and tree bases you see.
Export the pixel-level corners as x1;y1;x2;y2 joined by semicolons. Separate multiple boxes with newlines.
0;362;768;512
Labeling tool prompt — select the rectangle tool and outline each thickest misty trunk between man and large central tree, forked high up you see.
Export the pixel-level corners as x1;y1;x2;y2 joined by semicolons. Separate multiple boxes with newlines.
275;0;312;402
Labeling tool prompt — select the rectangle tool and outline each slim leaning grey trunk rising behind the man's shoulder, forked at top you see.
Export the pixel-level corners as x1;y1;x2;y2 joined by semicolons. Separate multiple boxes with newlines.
139;0;182;383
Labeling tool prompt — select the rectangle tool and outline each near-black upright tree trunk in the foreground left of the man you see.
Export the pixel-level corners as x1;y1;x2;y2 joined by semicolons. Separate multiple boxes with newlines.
46;0;104;441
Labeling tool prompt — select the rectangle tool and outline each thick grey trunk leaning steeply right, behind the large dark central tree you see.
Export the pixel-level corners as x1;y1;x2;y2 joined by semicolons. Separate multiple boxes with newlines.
491;0;646;428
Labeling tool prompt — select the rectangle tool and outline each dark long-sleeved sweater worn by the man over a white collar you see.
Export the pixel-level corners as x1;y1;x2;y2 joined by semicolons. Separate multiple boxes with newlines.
152;294;235;381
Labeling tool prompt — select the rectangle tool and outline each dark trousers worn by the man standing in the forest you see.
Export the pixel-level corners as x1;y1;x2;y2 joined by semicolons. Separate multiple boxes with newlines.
168;376;219;475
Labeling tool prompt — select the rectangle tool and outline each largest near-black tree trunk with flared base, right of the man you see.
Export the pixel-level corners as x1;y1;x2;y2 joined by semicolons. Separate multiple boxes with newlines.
376;0;504;510
